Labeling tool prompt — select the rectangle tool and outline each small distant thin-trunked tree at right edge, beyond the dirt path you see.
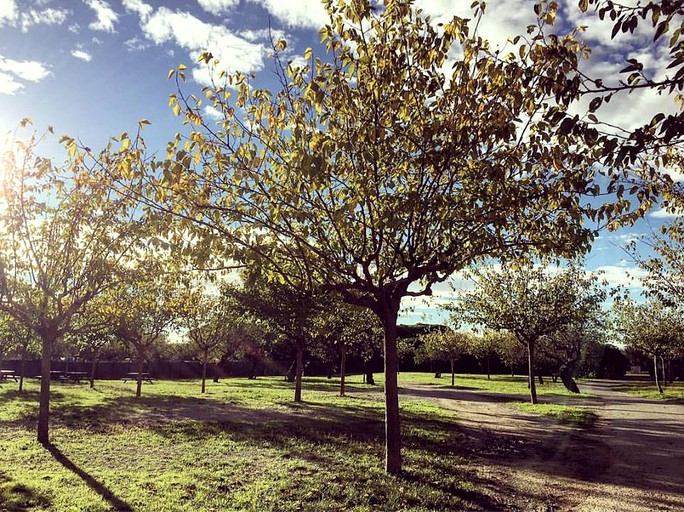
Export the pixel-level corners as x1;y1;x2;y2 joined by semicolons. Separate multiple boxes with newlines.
615;300;684;393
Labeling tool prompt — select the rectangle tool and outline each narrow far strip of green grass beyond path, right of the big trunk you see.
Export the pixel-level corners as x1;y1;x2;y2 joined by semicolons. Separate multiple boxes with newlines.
399;372;593;398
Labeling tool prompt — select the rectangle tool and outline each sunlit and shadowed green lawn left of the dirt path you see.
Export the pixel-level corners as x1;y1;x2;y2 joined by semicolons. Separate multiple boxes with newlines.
0;374;588;512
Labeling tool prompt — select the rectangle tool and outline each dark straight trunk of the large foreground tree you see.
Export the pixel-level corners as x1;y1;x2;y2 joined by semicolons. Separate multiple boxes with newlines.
381;298;401;475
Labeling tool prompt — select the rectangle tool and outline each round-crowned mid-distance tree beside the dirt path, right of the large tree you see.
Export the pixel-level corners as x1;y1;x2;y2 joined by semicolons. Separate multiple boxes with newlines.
456;262;606;404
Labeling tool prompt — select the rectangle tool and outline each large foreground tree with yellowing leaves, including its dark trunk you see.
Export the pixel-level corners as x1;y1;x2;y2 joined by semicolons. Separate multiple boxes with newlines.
148;0;652;473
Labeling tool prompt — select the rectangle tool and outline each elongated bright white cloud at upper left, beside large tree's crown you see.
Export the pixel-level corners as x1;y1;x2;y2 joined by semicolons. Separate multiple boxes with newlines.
134;7;265;84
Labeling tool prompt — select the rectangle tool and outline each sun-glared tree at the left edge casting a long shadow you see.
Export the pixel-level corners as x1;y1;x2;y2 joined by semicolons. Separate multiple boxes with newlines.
0;124;143;444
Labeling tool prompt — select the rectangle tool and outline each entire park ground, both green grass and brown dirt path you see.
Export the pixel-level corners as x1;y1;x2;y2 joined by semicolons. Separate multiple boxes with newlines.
0;373;684;512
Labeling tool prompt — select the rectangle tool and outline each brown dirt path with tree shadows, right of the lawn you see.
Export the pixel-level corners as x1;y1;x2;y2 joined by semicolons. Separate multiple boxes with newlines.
401;381;684;512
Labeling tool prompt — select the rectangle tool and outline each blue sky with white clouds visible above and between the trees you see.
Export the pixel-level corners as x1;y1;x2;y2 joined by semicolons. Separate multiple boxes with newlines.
0;0;684;319
